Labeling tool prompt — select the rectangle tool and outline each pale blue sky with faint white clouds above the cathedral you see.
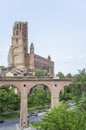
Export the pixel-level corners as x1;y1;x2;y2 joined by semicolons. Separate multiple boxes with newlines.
0;0;86;75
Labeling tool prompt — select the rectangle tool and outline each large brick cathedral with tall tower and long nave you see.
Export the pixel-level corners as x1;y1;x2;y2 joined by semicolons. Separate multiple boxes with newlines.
0;22;54;76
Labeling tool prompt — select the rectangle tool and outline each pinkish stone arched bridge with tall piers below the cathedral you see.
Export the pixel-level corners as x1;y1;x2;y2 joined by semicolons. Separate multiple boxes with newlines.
0;77;71;126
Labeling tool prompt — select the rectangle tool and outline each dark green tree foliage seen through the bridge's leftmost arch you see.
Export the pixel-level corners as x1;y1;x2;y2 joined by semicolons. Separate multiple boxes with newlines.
0;86;20;113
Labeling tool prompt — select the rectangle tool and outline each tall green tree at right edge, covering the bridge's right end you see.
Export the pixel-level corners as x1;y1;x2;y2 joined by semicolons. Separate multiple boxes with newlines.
60;71;86;110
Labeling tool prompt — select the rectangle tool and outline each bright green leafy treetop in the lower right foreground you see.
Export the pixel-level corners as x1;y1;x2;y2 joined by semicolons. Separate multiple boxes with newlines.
40;103;86;130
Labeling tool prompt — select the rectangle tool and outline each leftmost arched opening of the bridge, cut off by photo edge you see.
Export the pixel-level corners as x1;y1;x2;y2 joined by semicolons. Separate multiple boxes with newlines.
0;84;21;124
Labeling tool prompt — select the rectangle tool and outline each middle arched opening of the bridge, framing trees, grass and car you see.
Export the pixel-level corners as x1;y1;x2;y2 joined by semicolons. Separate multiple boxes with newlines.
28;84;51;123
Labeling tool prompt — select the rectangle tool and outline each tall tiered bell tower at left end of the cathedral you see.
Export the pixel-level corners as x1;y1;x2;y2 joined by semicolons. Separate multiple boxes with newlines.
8;22;28;69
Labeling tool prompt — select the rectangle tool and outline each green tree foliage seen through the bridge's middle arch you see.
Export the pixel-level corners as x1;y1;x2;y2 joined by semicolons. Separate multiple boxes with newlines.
28;87;51;107
